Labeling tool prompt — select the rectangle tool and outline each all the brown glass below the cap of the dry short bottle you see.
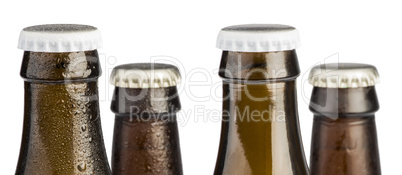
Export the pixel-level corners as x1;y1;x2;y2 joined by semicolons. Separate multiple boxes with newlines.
310;86;381;175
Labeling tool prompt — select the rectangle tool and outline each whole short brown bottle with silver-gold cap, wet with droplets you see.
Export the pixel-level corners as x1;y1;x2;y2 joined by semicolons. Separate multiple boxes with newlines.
110;63;183;175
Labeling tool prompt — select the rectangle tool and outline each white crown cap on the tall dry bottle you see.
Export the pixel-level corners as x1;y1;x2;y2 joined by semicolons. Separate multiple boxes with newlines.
216;24;300;52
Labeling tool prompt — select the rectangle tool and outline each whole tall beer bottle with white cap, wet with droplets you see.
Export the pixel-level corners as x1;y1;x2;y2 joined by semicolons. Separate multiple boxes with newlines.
16;24;111;174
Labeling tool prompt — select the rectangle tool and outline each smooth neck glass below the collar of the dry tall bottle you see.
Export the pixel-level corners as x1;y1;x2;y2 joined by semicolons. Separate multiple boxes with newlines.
218;81;307;174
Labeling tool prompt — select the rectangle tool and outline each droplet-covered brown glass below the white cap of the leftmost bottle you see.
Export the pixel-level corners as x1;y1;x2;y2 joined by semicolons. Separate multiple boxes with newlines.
16;52;110;174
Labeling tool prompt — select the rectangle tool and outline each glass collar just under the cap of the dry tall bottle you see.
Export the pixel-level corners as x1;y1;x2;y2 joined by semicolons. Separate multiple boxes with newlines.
219;50;300;83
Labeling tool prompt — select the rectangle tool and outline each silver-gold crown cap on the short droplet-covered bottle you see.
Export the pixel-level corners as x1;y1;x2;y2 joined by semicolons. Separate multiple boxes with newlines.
110;63;181;88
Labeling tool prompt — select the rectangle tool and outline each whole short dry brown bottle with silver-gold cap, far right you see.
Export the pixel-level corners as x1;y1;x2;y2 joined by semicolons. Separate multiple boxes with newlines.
309;63;381;175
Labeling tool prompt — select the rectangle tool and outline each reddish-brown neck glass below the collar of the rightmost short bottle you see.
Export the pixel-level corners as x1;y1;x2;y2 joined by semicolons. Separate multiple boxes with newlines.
310;115;381;175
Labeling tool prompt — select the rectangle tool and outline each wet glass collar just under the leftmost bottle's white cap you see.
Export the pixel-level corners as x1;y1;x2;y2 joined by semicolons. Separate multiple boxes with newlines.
20;50;101;83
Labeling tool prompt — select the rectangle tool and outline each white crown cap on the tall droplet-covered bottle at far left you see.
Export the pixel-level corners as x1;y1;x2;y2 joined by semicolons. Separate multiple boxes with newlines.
18;24;102;52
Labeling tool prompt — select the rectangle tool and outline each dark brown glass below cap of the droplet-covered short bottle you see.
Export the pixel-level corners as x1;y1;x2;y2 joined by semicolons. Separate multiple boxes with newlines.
111;87;183;175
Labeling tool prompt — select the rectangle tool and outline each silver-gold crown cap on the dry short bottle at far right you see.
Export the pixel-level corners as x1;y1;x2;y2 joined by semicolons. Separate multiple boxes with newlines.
309;63;380;88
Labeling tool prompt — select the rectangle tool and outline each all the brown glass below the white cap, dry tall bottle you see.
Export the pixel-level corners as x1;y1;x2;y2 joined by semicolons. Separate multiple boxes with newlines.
215;51;308;174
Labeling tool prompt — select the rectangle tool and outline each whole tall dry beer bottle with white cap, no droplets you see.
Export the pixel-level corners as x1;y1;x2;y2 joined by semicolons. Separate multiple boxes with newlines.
214;25;309;175
